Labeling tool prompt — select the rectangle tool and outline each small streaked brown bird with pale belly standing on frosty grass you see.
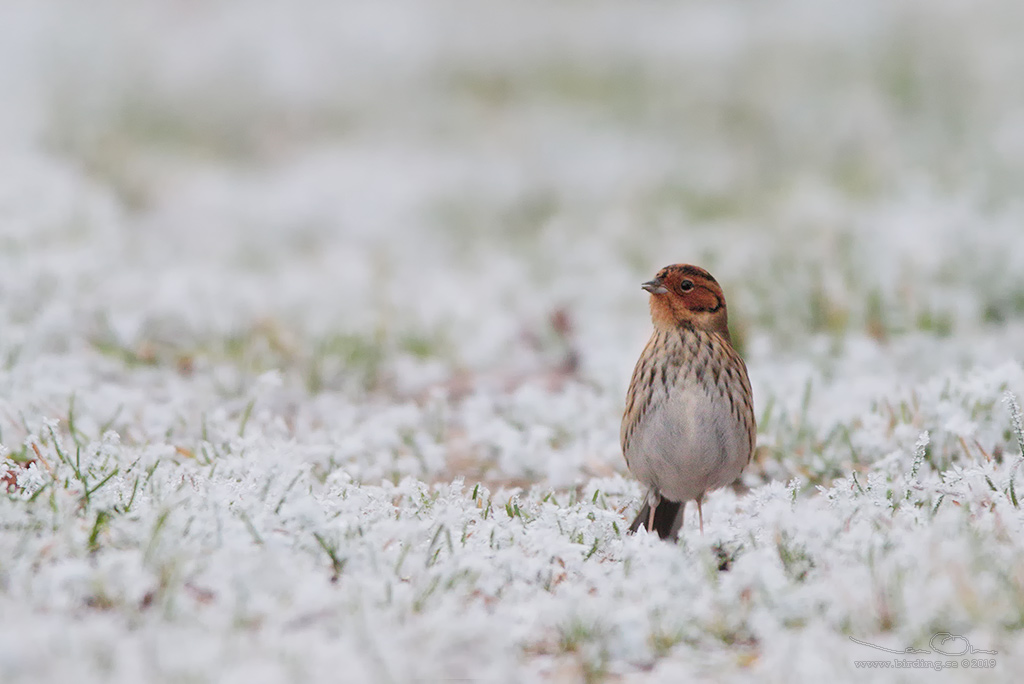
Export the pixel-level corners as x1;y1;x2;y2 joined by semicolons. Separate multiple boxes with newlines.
620;264;757;541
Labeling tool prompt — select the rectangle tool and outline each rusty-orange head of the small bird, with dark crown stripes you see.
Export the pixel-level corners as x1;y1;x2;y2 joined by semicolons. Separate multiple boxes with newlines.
642;263;729;339
